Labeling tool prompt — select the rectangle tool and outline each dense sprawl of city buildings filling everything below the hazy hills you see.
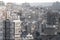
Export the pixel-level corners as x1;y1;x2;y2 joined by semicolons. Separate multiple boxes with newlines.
0;1;60;40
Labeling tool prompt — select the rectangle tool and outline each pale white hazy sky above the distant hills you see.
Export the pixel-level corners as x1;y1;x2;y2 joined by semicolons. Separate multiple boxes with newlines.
1;0;60;3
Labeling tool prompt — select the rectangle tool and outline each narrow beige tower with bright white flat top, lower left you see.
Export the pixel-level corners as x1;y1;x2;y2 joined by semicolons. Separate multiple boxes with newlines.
13;20;22;40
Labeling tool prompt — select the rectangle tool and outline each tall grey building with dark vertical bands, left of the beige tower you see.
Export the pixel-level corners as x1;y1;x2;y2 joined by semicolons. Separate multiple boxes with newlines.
3;19;15;40
